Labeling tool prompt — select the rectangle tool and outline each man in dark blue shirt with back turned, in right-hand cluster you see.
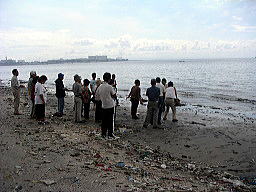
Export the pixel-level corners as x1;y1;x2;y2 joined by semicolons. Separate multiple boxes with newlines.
143;79;160;128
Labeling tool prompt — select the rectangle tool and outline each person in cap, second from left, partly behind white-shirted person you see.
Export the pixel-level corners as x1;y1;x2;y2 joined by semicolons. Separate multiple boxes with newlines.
28;71;38;118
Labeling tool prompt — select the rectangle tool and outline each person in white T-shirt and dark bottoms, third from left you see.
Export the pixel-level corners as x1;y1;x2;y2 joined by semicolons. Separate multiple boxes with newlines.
35;75;47;123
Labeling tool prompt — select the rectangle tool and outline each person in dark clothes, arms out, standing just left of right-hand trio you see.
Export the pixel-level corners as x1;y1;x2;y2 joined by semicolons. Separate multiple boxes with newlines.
127;79;143;119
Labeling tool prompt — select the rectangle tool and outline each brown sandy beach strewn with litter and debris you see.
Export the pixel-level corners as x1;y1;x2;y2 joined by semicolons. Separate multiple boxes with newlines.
0;87;256;191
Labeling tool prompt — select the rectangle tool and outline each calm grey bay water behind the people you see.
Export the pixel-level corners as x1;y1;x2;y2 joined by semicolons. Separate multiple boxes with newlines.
0;58;256;120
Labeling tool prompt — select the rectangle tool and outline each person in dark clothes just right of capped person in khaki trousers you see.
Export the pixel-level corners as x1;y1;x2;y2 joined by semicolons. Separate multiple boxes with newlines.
82;79;92;119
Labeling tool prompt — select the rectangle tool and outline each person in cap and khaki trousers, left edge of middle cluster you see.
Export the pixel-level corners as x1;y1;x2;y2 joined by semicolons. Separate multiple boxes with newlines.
72;74;83;123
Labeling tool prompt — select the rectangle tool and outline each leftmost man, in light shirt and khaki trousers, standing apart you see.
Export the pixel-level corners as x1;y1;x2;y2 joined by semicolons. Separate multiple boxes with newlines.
11;69;23;115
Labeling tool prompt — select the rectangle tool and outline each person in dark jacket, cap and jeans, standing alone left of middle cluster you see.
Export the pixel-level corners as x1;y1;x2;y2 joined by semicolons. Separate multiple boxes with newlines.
55;73;66;117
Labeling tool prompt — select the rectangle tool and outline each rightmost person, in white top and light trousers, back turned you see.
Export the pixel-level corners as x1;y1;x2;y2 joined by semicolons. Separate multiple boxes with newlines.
163;81;178;122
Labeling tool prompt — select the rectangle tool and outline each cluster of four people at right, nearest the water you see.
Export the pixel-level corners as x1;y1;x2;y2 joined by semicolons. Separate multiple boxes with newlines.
127;77;178;128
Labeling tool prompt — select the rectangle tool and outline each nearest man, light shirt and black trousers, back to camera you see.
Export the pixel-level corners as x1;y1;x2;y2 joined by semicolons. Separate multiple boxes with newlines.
96;72;116;139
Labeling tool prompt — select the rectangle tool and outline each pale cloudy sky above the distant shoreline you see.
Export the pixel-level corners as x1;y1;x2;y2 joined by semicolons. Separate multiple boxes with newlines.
0;0;256;61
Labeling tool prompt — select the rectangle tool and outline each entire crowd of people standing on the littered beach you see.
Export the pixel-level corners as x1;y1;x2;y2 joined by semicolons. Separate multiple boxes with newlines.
11;69;178;139
